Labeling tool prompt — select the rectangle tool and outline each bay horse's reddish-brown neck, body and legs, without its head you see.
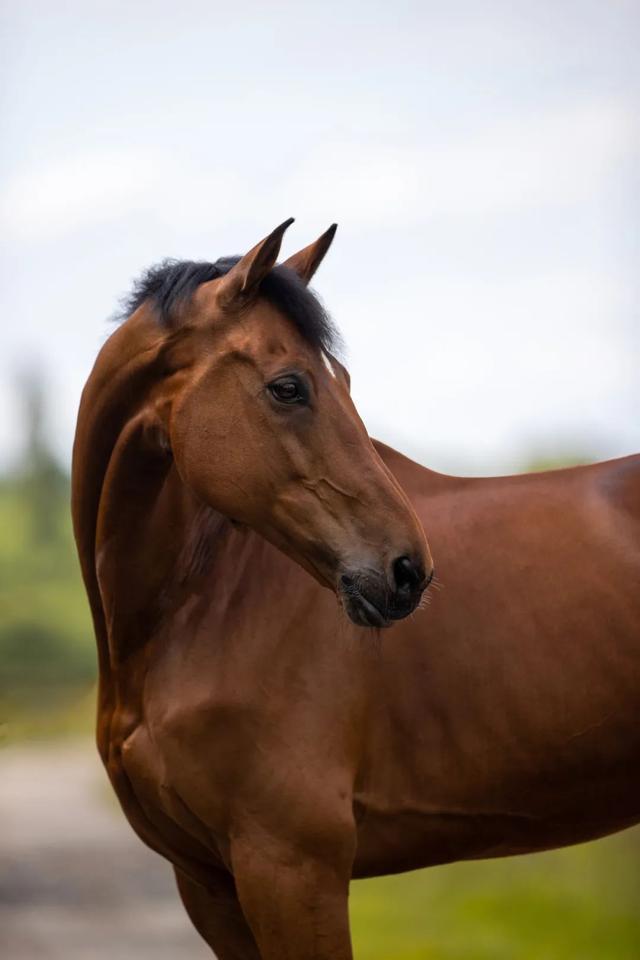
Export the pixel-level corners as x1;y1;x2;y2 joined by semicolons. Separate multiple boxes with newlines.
74;221;640;960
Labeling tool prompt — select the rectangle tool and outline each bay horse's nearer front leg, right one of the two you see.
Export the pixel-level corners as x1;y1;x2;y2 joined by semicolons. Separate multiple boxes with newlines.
231;808;355;960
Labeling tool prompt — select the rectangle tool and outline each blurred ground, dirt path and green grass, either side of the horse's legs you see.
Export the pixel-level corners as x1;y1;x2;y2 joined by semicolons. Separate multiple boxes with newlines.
0;739;640;960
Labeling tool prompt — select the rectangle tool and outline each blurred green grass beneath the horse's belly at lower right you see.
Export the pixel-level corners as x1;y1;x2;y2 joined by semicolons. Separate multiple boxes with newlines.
350;829;640;960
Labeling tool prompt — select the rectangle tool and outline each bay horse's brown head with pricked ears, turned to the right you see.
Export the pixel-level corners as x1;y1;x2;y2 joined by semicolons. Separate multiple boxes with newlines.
149;221;432;626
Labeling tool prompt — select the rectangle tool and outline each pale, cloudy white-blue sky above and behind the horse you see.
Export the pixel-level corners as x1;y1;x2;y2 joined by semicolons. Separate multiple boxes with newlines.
0;0;640;474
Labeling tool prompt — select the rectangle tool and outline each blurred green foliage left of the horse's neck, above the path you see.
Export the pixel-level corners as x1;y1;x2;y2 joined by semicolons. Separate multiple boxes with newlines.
0;464;96;740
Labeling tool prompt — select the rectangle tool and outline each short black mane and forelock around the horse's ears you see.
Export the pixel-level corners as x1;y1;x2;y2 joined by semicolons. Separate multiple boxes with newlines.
120;257;340;353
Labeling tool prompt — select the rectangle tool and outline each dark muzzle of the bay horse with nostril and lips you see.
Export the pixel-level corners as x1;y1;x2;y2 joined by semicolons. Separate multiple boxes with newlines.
338;556;433;627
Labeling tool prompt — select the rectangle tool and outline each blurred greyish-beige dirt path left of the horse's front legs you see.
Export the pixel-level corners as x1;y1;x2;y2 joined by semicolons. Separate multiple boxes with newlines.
0;743;213;960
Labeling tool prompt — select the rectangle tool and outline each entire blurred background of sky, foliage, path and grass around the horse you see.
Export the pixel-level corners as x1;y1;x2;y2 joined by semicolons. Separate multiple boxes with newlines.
0;0;640;960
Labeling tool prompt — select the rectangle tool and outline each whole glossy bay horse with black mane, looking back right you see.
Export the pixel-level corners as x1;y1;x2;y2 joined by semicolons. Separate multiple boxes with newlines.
72;221;640;960
